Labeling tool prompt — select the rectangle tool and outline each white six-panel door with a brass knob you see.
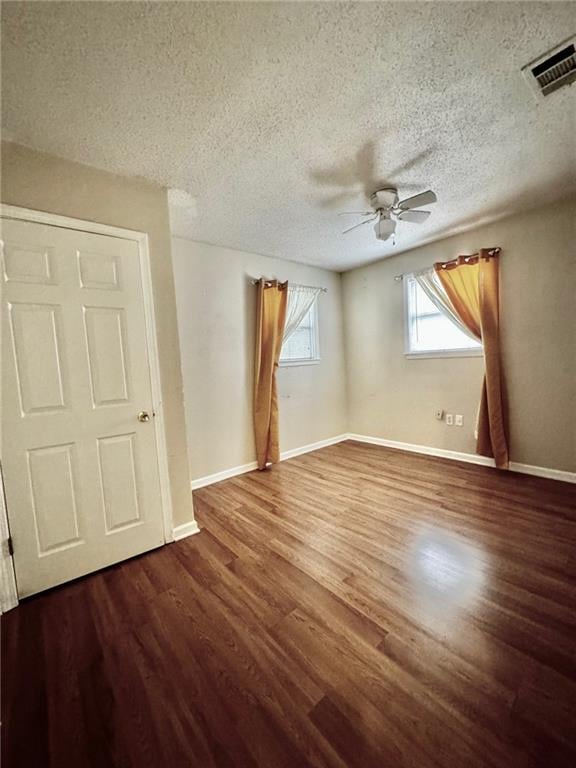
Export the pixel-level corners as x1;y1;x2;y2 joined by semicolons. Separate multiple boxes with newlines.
2;220;164;597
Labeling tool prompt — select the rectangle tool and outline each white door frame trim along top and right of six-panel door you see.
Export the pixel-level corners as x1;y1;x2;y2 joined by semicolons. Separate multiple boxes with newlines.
0;203;174;600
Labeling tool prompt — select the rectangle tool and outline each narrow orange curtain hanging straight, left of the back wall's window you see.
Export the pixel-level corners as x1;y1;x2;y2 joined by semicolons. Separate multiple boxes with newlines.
254;279;288;469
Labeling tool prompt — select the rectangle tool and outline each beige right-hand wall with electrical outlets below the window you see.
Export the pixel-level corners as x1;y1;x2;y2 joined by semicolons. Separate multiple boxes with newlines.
343;200;576;471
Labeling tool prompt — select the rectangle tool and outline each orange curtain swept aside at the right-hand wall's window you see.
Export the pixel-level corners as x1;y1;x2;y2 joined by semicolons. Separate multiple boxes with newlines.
434;249;509;469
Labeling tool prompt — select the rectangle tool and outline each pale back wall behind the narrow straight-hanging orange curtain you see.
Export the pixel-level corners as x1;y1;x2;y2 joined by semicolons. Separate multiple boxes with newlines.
172;238;346;479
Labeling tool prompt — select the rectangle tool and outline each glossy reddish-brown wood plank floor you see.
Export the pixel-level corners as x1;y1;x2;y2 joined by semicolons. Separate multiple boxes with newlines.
2;442;576;768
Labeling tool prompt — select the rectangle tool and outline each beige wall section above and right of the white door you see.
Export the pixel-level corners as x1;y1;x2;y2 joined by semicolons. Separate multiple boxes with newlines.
1;143;193;525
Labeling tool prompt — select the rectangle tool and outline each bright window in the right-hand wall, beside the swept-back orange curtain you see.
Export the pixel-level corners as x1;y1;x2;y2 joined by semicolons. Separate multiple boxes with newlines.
404;275;482;357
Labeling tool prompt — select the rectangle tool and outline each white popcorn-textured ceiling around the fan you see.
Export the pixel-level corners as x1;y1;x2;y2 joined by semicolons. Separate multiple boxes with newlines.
2;2;576;269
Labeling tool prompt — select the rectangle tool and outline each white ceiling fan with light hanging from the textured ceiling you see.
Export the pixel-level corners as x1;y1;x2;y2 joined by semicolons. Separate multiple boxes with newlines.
339;187;436;240
